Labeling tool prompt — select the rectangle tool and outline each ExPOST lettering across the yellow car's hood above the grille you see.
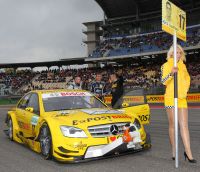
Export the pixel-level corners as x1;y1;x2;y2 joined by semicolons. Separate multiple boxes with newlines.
72;115;132;125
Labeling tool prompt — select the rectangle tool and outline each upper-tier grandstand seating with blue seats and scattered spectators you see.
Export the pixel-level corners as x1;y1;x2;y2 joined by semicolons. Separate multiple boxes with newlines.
89;26;200;58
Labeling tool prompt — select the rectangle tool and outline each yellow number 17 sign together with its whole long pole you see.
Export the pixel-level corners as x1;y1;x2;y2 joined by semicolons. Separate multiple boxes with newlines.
162;0;187;168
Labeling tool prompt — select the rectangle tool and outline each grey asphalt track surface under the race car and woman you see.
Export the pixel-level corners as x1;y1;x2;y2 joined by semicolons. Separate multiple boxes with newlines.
0;108;200;172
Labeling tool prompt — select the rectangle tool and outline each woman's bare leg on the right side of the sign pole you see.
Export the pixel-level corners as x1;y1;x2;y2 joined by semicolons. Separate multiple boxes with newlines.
178;108;193;159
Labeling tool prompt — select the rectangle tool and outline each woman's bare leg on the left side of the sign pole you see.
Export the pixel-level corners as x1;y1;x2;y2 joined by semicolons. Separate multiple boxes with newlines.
167;108;175;157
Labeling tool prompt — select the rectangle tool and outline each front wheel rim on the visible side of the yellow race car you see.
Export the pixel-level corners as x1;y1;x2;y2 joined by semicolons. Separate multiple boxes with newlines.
40;127;51;156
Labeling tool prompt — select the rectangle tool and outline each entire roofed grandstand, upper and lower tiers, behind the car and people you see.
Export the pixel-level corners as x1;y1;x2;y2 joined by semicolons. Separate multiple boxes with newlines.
0;0;200;99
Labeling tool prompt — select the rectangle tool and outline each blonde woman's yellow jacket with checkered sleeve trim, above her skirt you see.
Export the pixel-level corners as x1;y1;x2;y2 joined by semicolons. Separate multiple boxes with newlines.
161;58;190;99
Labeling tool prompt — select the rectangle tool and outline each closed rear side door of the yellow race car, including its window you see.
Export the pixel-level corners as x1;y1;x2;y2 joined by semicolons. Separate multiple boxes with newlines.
16;93;31;136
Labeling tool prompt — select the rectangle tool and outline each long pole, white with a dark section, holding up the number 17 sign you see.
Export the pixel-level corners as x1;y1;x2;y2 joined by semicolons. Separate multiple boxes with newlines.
173;30;178;168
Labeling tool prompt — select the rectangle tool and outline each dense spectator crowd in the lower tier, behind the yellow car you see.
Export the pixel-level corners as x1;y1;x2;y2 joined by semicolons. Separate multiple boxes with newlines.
0;56;200;94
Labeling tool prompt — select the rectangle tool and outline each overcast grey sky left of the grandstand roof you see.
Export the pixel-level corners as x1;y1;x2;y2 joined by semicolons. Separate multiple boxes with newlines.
0;0;103;63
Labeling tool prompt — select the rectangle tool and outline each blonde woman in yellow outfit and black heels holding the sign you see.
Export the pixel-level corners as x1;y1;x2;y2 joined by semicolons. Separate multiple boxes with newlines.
161;45;196;163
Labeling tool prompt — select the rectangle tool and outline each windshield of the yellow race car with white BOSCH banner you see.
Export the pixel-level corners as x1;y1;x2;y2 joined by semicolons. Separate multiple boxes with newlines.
42;92;106;112
